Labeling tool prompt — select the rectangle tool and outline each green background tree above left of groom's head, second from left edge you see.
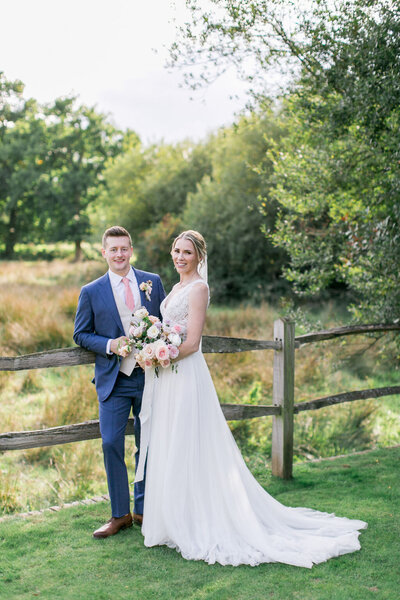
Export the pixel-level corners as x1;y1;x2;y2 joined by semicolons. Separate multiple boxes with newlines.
47;97;124;260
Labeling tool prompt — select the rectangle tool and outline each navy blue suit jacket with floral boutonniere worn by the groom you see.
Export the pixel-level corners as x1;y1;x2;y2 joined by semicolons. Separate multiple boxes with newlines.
74;269;165;402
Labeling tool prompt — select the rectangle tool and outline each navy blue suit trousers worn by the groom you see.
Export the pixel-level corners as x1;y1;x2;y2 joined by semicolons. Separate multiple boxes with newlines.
99;368;145;518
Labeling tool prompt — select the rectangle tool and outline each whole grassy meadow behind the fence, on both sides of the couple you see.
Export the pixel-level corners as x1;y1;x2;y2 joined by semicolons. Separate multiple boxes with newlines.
0;259;400;514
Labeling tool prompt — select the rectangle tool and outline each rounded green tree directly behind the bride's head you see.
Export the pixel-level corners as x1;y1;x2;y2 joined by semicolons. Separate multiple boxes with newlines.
182;110;286;301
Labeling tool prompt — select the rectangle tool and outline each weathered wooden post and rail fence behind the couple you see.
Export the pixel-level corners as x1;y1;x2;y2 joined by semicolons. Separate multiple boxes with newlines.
0;319;400;479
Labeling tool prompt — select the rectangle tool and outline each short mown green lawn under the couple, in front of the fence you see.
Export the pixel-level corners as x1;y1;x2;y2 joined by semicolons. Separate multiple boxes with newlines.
0;448;400;600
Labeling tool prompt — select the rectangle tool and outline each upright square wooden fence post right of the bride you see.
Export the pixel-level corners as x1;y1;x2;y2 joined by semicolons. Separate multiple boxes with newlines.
272;319;295;479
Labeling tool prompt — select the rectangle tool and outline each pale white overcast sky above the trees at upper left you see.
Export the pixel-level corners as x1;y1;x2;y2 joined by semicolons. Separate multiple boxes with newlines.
0;0;250;143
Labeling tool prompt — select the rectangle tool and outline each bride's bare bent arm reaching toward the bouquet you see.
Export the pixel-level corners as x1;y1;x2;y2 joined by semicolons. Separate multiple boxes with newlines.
174;284;208;362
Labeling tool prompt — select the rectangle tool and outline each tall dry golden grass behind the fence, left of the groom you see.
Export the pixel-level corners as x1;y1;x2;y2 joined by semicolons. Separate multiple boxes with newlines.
0;260;110;512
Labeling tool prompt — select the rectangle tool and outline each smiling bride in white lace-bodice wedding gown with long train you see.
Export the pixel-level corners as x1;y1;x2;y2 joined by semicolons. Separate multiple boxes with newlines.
136;230;367;568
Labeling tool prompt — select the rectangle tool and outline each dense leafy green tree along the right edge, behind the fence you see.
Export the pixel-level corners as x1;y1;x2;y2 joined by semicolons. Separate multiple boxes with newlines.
268;3;400;321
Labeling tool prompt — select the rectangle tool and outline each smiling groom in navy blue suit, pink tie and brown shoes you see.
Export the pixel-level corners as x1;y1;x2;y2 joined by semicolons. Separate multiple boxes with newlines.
74;226;165;538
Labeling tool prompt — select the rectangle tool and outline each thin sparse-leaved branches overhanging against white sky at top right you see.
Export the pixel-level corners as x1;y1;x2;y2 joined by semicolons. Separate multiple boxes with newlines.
170;0;399;101
